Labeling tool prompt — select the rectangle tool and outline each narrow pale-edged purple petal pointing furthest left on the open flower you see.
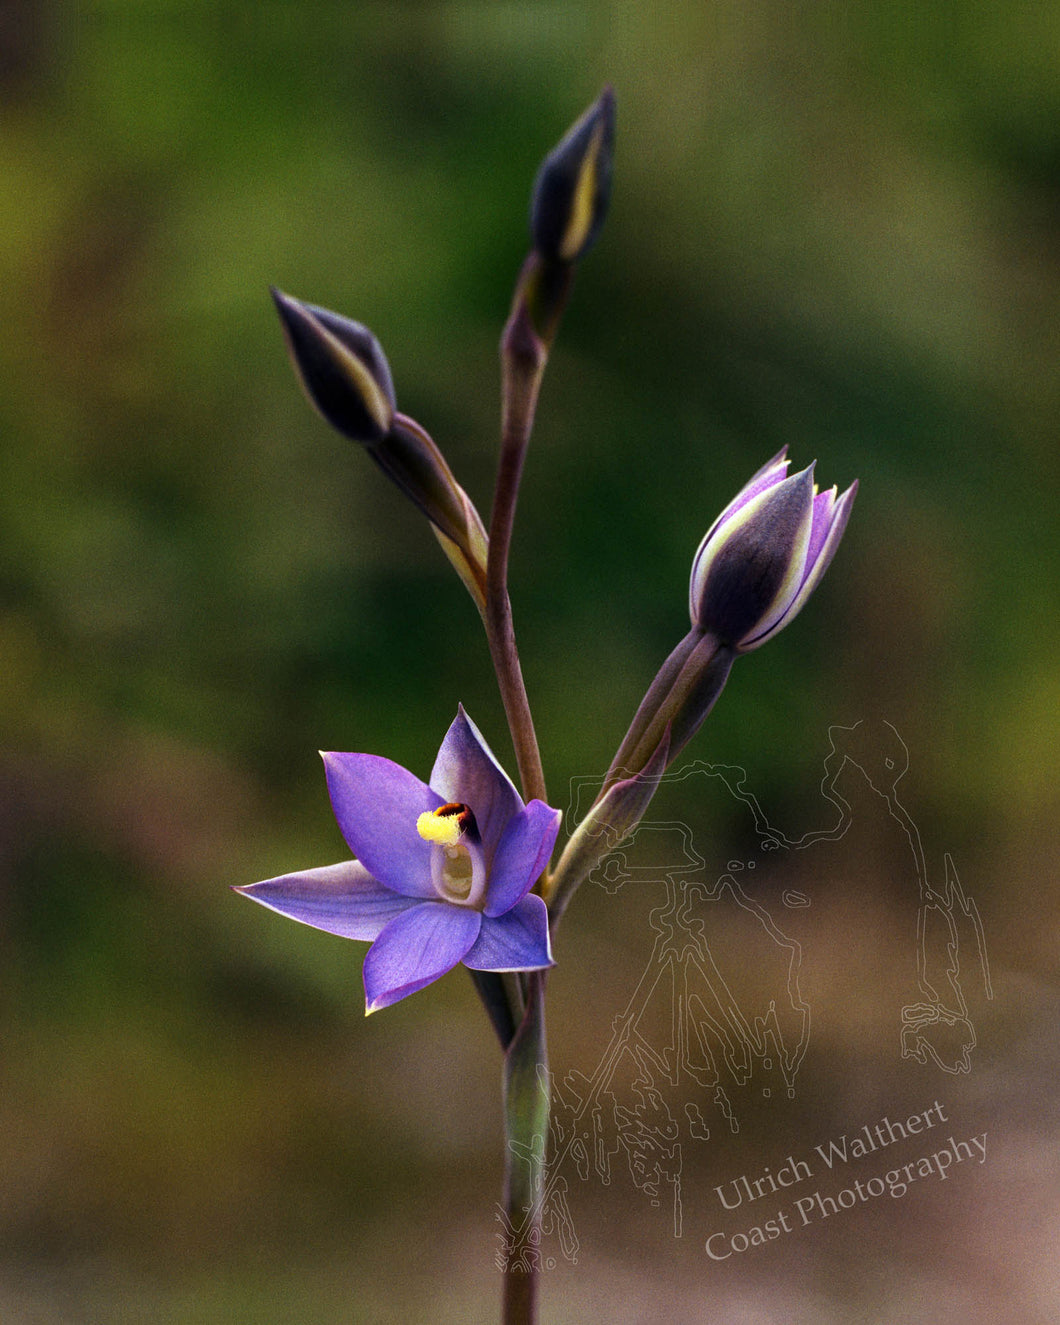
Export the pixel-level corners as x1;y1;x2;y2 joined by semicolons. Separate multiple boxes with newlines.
235;860;417;941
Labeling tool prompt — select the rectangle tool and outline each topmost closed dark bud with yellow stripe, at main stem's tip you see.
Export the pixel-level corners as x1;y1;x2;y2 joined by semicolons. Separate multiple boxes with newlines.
530;86;615;262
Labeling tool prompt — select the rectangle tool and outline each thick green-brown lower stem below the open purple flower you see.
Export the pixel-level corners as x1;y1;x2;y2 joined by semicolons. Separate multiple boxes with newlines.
502;971;551;1325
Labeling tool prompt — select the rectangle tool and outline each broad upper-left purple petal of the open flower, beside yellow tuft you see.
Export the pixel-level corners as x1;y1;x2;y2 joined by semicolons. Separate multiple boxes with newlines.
323;753;443;897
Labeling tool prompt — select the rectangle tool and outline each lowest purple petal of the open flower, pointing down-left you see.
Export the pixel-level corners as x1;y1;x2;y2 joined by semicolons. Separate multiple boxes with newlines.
364;902;482;1015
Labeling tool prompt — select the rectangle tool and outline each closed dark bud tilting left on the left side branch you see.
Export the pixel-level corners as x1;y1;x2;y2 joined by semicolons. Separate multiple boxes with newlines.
273;290;396;445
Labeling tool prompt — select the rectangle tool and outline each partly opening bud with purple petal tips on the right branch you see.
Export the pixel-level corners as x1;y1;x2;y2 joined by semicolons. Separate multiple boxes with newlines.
689;448;857;653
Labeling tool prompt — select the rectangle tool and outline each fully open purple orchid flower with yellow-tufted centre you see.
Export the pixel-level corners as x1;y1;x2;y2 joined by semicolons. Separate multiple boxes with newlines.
235;706;562;1015
